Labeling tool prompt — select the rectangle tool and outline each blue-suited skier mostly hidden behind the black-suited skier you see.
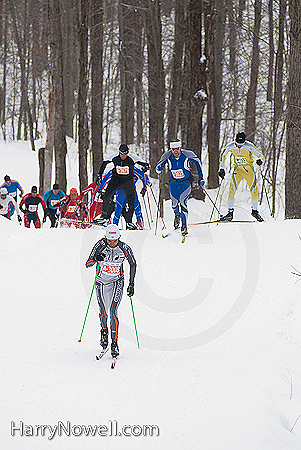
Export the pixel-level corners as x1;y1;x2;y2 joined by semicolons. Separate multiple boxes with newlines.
98;167;151;230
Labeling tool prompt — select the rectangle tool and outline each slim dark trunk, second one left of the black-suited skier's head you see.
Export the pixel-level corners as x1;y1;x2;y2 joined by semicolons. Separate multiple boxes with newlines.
78;0;90;191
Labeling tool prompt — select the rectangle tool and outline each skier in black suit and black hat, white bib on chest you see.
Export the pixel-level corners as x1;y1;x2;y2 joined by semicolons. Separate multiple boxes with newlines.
96;144;149;229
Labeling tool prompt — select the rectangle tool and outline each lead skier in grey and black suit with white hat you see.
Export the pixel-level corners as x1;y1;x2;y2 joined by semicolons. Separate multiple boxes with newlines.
86;224;137;357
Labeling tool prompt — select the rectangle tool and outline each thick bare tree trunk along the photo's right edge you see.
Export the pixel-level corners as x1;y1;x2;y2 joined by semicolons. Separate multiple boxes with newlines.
285;0;301;219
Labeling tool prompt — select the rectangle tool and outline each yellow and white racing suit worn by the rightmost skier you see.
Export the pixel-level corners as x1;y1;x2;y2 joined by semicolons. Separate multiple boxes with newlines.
220;141;264;210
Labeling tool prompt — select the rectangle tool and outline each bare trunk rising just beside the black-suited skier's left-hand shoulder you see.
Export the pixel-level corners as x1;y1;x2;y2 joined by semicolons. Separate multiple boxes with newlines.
91;0;104;180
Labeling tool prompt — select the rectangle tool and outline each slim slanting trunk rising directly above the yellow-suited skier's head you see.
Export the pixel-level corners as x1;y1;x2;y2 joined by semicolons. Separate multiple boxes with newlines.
245;0;262;142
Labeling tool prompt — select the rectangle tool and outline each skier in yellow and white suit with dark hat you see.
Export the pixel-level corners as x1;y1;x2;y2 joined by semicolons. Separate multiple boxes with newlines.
218;132;264;222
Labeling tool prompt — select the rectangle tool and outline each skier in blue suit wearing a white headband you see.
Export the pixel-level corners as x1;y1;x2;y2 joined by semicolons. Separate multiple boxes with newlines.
156;141;205;236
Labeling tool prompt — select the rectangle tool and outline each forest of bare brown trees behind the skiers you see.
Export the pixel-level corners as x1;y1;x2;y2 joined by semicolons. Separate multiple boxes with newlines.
0;0;301;218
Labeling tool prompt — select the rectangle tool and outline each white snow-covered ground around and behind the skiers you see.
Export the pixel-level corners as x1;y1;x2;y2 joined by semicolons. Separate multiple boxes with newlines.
0;143;301;450
